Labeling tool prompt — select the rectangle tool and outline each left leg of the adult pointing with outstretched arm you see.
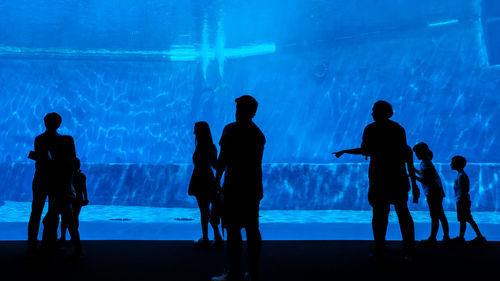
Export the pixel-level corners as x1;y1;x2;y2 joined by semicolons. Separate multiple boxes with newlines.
372;200;390;254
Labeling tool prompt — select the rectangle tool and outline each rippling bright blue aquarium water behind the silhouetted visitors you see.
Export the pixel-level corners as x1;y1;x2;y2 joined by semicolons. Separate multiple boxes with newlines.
0;0;500;238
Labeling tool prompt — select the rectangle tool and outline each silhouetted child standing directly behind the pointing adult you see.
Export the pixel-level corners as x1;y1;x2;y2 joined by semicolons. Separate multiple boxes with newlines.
413;142;450;245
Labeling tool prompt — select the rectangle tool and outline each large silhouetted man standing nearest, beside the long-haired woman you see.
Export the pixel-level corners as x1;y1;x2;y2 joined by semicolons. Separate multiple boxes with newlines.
212;95;266;280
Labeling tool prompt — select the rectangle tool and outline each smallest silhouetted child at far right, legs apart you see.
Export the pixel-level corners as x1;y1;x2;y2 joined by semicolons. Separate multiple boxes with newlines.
450;156;486;244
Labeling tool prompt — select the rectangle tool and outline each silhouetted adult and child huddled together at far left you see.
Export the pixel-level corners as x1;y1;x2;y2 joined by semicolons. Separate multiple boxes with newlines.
28;113;88;258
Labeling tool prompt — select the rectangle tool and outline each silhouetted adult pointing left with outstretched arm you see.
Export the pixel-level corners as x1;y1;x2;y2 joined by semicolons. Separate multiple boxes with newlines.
335;101;420;261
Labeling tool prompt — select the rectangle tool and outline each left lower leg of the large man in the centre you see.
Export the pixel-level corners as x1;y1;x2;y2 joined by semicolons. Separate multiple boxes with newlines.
227;225;243;280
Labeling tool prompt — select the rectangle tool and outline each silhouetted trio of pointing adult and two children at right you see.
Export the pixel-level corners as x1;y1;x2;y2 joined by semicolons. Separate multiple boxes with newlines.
334;101;486;261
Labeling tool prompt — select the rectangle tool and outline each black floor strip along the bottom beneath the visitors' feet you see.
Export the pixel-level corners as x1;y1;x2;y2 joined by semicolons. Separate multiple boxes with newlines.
0;241;500;281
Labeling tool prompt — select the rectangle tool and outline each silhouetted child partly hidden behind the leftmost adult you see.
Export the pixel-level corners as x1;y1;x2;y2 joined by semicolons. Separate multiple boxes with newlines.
59;158;89;242
